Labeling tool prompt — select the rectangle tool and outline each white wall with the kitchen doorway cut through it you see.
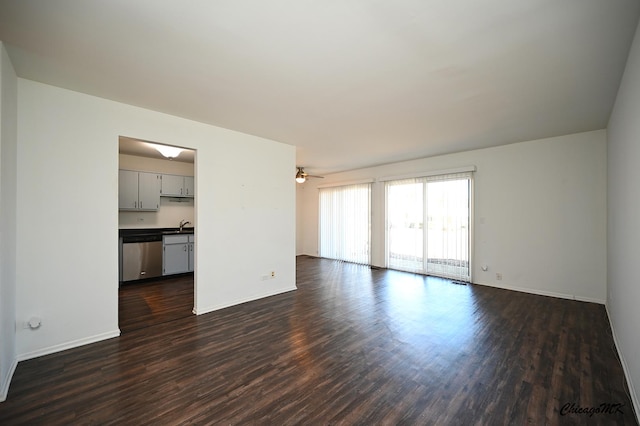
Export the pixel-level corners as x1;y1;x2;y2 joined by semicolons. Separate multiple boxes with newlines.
16;79;295;359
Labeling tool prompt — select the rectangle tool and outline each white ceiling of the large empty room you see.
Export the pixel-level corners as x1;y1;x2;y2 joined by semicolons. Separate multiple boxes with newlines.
0;0;640;174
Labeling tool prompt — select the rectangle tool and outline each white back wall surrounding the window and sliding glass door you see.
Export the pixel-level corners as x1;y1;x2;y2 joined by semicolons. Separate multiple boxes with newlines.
297;130;607;303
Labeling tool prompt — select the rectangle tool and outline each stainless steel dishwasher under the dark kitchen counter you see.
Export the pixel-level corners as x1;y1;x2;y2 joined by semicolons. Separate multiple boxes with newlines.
122;234;162;281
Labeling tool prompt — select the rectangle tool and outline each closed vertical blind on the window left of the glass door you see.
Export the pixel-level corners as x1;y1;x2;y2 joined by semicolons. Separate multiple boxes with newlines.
320;183;371;264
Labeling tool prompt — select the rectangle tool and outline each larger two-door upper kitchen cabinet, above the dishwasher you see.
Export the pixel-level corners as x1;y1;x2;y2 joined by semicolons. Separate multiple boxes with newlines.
118;170;161;211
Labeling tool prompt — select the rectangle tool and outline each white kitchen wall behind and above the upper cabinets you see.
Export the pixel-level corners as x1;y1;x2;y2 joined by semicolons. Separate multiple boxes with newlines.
118;153;195;228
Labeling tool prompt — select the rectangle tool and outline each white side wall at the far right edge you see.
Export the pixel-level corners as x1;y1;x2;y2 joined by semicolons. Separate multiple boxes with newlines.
607;17;640;420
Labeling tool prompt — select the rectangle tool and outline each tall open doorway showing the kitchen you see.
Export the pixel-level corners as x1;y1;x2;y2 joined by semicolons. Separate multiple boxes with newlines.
118;136;196;333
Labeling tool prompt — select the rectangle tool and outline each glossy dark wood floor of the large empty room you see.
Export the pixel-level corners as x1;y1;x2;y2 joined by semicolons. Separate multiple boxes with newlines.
0;257;637;425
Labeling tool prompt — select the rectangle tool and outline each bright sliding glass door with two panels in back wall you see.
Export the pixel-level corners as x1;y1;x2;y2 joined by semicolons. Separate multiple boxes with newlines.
386;173;472;281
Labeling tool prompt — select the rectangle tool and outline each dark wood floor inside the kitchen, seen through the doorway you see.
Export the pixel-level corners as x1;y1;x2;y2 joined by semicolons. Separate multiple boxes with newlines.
118;274;193;333
